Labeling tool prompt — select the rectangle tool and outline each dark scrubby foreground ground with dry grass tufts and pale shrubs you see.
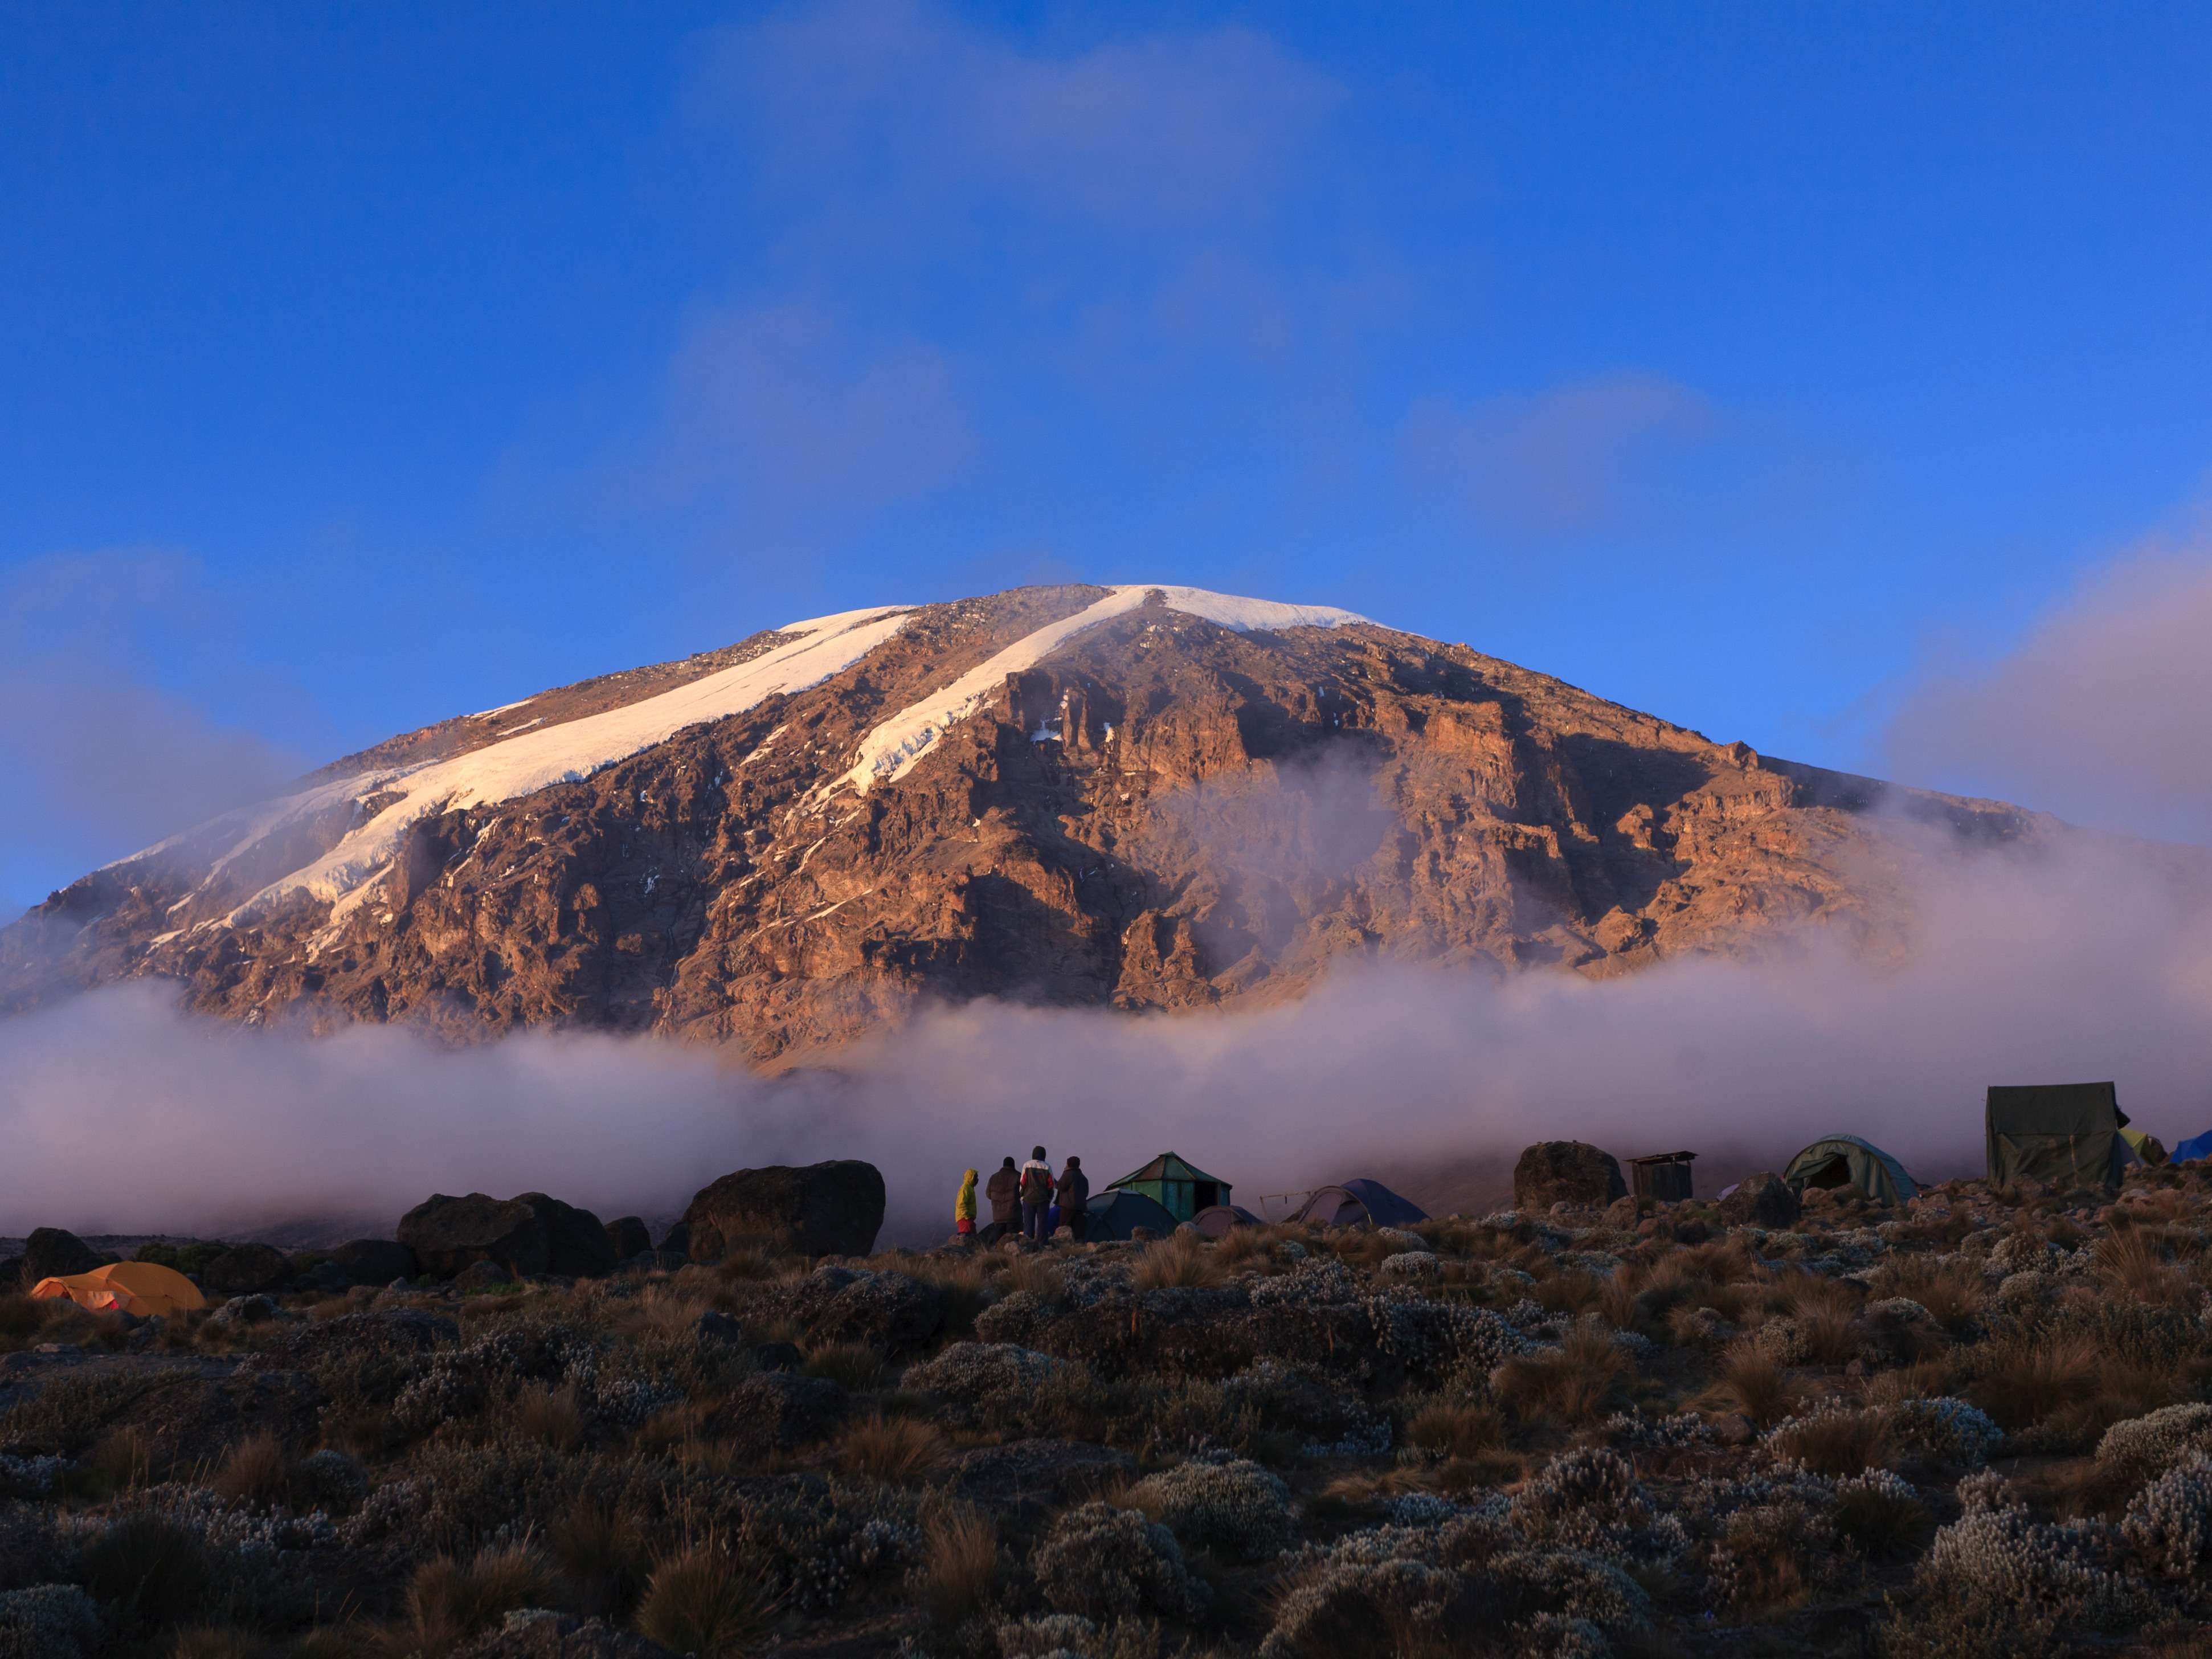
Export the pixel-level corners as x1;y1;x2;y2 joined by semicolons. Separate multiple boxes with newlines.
0;1168;2212;1659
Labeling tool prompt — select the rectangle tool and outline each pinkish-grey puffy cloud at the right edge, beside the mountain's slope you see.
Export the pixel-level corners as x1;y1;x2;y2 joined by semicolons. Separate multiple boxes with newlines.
1887;540;2212;843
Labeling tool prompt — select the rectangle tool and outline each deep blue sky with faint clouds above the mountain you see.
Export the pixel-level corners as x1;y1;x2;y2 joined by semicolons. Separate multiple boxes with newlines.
0;0;2212;912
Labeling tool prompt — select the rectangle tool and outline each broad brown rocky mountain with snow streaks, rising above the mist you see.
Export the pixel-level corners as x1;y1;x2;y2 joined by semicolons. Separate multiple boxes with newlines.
0;586;2046;1062
